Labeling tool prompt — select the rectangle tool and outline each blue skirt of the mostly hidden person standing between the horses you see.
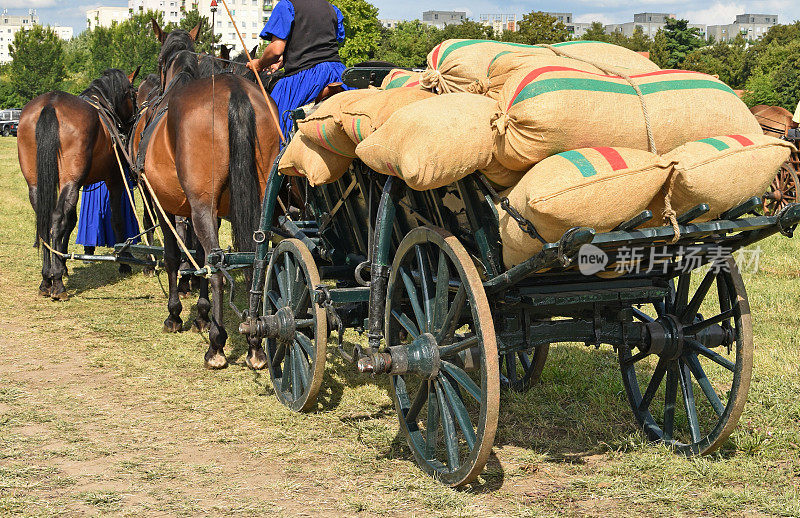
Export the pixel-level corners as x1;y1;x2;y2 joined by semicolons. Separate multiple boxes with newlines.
75;182;139;247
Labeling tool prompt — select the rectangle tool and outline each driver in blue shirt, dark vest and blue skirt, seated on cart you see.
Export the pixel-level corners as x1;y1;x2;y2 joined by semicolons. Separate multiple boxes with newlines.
252;0;345;140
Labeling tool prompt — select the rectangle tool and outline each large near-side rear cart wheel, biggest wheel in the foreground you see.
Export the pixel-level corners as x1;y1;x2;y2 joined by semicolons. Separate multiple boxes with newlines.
386;227;500;486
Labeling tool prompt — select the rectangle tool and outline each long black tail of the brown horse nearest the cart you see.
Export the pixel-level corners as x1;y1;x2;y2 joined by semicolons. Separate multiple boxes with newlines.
228;79;261;252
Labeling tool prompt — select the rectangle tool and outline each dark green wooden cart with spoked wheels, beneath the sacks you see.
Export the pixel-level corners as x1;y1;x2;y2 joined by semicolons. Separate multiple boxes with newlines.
181;70;800;486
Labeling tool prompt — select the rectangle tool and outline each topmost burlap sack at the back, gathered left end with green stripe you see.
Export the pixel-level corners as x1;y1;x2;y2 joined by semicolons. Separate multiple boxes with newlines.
420;40;658;94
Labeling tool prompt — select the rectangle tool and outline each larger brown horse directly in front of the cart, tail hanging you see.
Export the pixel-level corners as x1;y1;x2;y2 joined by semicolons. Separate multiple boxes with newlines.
144;21;280;369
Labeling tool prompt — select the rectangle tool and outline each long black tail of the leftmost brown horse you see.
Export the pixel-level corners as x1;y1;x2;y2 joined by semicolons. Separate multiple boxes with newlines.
36;104;61;250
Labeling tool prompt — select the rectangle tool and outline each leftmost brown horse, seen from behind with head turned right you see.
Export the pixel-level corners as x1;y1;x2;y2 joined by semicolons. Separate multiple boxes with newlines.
17;69;139;300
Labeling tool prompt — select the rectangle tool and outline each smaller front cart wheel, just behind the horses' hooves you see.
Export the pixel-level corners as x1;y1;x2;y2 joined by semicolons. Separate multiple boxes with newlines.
263;239;328;412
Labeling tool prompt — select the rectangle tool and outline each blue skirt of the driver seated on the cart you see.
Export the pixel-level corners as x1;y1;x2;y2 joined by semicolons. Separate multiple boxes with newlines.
272;61;349;140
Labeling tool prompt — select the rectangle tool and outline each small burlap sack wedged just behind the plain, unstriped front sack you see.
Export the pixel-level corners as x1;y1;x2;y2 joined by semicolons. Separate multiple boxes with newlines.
341;88;436;144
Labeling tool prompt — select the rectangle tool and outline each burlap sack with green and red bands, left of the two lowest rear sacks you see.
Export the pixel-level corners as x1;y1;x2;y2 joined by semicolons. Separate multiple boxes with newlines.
497;147;673;268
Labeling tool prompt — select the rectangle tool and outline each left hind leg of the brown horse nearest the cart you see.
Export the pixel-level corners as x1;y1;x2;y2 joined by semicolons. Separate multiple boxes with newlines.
192;204;228;369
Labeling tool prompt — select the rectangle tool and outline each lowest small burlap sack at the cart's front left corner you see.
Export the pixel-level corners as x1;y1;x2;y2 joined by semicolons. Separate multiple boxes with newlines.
278;133;353;186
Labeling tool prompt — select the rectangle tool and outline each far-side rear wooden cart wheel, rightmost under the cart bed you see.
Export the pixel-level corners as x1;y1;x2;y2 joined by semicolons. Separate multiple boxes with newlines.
619;256;753;455
